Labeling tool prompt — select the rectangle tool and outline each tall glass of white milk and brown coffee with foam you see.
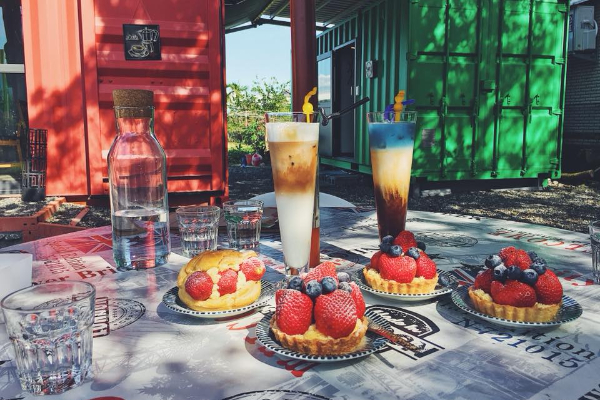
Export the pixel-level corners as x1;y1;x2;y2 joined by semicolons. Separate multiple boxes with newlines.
266;113;319;274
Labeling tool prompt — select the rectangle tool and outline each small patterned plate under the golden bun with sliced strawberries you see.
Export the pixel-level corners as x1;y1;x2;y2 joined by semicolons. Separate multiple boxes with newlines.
163;281;275;318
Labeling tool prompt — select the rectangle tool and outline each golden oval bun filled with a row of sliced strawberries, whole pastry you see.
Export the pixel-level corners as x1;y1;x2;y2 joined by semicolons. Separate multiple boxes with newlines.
177;250;265;311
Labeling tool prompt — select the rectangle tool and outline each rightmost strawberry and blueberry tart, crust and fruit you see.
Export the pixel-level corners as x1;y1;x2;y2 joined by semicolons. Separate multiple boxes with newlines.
468;246;563;322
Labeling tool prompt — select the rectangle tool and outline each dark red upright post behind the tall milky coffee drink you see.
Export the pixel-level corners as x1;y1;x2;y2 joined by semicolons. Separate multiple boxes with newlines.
290;0;320;267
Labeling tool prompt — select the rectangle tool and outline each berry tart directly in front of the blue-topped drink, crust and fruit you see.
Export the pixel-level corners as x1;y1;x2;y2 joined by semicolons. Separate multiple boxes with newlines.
363;231;438;294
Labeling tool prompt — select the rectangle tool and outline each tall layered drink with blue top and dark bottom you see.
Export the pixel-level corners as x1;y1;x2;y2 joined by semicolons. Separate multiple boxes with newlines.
367;111;417;239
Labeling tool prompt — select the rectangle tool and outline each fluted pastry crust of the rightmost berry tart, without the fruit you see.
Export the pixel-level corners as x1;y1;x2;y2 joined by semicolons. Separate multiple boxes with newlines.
468;286;562;322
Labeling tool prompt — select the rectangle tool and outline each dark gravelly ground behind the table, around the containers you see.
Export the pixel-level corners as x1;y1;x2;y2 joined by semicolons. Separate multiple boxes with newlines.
0;166;600;238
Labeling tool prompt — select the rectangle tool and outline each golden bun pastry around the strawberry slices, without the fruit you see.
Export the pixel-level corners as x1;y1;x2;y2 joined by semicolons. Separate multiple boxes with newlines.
177;249;261;311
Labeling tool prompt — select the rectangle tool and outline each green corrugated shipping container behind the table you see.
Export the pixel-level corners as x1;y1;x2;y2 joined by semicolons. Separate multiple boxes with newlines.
317;0;568;181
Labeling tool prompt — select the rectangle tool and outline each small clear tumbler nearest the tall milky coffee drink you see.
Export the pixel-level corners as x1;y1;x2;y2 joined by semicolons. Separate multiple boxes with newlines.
223;200;263;249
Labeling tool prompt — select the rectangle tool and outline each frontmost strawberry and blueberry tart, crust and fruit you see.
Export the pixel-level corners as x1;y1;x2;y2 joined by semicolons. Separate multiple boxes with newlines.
270;262;368;355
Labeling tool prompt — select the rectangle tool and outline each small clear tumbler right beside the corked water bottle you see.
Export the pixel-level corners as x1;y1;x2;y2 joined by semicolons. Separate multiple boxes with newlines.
175;206;221;257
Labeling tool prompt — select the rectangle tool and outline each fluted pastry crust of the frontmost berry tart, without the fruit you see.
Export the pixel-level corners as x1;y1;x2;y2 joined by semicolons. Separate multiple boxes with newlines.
270;315;368;356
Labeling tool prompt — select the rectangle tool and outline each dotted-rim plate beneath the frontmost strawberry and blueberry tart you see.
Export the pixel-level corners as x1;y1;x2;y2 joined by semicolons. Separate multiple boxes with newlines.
256;310;389;363
